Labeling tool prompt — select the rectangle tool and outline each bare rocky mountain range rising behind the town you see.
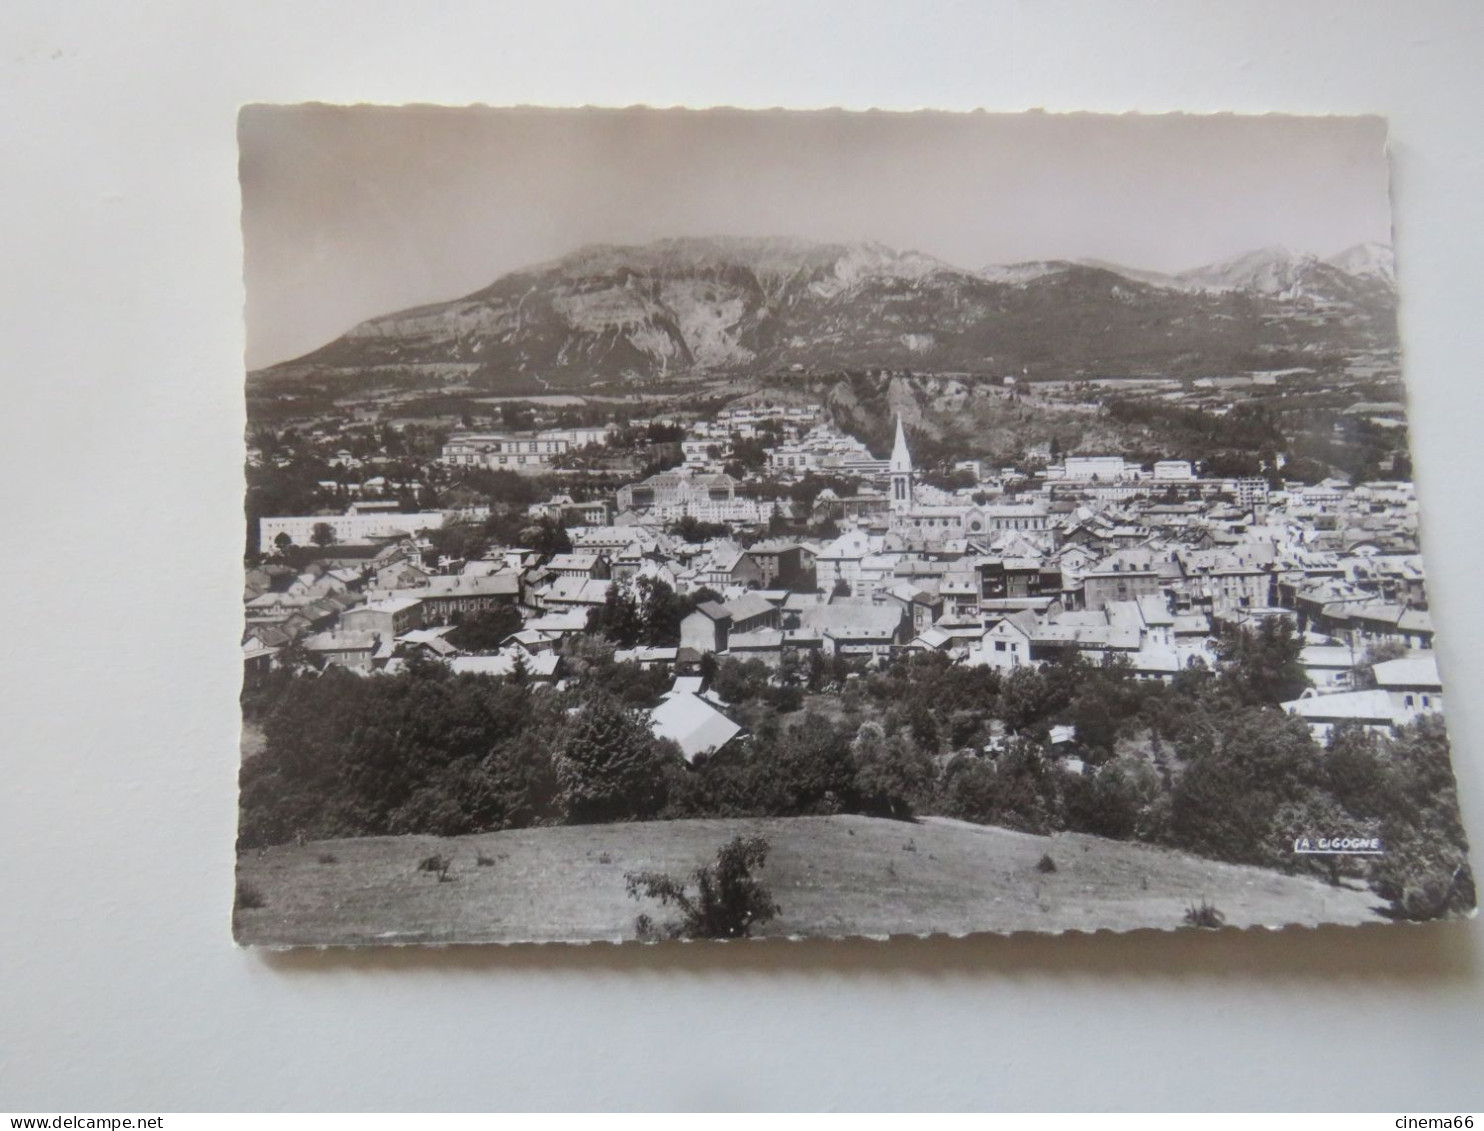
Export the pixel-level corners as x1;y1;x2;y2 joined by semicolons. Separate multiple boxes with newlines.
257;239;1395;389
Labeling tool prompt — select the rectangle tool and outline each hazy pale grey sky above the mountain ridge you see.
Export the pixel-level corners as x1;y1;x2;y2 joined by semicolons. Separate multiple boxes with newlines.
239;105;1391;368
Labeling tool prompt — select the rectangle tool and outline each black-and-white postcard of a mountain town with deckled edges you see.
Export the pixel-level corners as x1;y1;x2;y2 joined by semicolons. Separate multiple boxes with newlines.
233;105;1475;947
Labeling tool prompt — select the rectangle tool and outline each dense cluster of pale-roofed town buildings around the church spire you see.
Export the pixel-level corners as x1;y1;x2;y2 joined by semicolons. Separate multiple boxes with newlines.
243;422;1442;753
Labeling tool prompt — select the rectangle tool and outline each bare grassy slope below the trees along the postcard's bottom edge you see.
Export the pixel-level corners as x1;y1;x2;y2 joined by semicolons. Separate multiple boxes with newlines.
236;816;1379;947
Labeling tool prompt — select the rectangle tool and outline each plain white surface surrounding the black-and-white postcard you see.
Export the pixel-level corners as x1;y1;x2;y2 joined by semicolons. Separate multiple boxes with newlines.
0;0;1484;1112
